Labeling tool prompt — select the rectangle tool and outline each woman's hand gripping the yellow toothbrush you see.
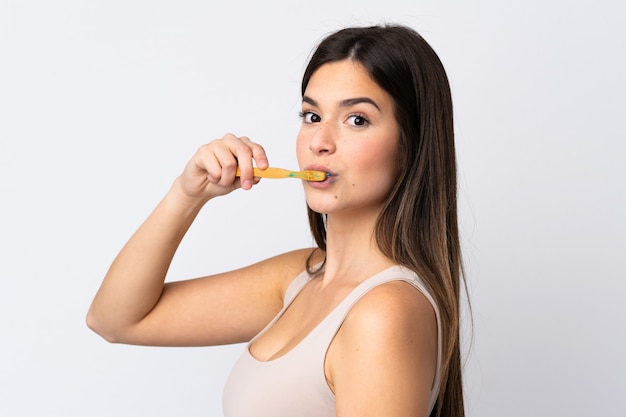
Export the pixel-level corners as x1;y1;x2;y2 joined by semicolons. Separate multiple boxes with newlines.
178;134;269;201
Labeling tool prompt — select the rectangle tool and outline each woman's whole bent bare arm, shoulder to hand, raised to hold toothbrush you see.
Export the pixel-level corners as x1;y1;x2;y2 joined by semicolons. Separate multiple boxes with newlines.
87;135;308;345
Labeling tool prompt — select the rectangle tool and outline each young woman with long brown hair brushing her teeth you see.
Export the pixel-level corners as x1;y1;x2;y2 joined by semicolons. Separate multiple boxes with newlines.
87;26;464;417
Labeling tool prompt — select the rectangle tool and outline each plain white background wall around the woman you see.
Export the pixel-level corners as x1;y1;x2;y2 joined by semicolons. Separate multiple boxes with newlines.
0;0;626;417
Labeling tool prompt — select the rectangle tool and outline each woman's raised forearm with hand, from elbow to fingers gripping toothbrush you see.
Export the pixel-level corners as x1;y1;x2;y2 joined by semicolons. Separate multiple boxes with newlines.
87;134;268;341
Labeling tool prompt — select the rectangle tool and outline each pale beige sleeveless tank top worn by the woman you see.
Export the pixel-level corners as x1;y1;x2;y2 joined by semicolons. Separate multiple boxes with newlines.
222;265;441;417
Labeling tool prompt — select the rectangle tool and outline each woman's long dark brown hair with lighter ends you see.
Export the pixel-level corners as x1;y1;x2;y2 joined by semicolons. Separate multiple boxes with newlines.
302;25;465;417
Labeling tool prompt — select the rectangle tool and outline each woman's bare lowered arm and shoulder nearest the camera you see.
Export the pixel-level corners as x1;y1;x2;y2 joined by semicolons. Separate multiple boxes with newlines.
325;281;437;417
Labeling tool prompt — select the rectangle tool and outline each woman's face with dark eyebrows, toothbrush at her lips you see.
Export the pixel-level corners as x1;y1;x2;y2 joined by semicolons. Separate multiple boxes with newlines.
297;60;400;215
